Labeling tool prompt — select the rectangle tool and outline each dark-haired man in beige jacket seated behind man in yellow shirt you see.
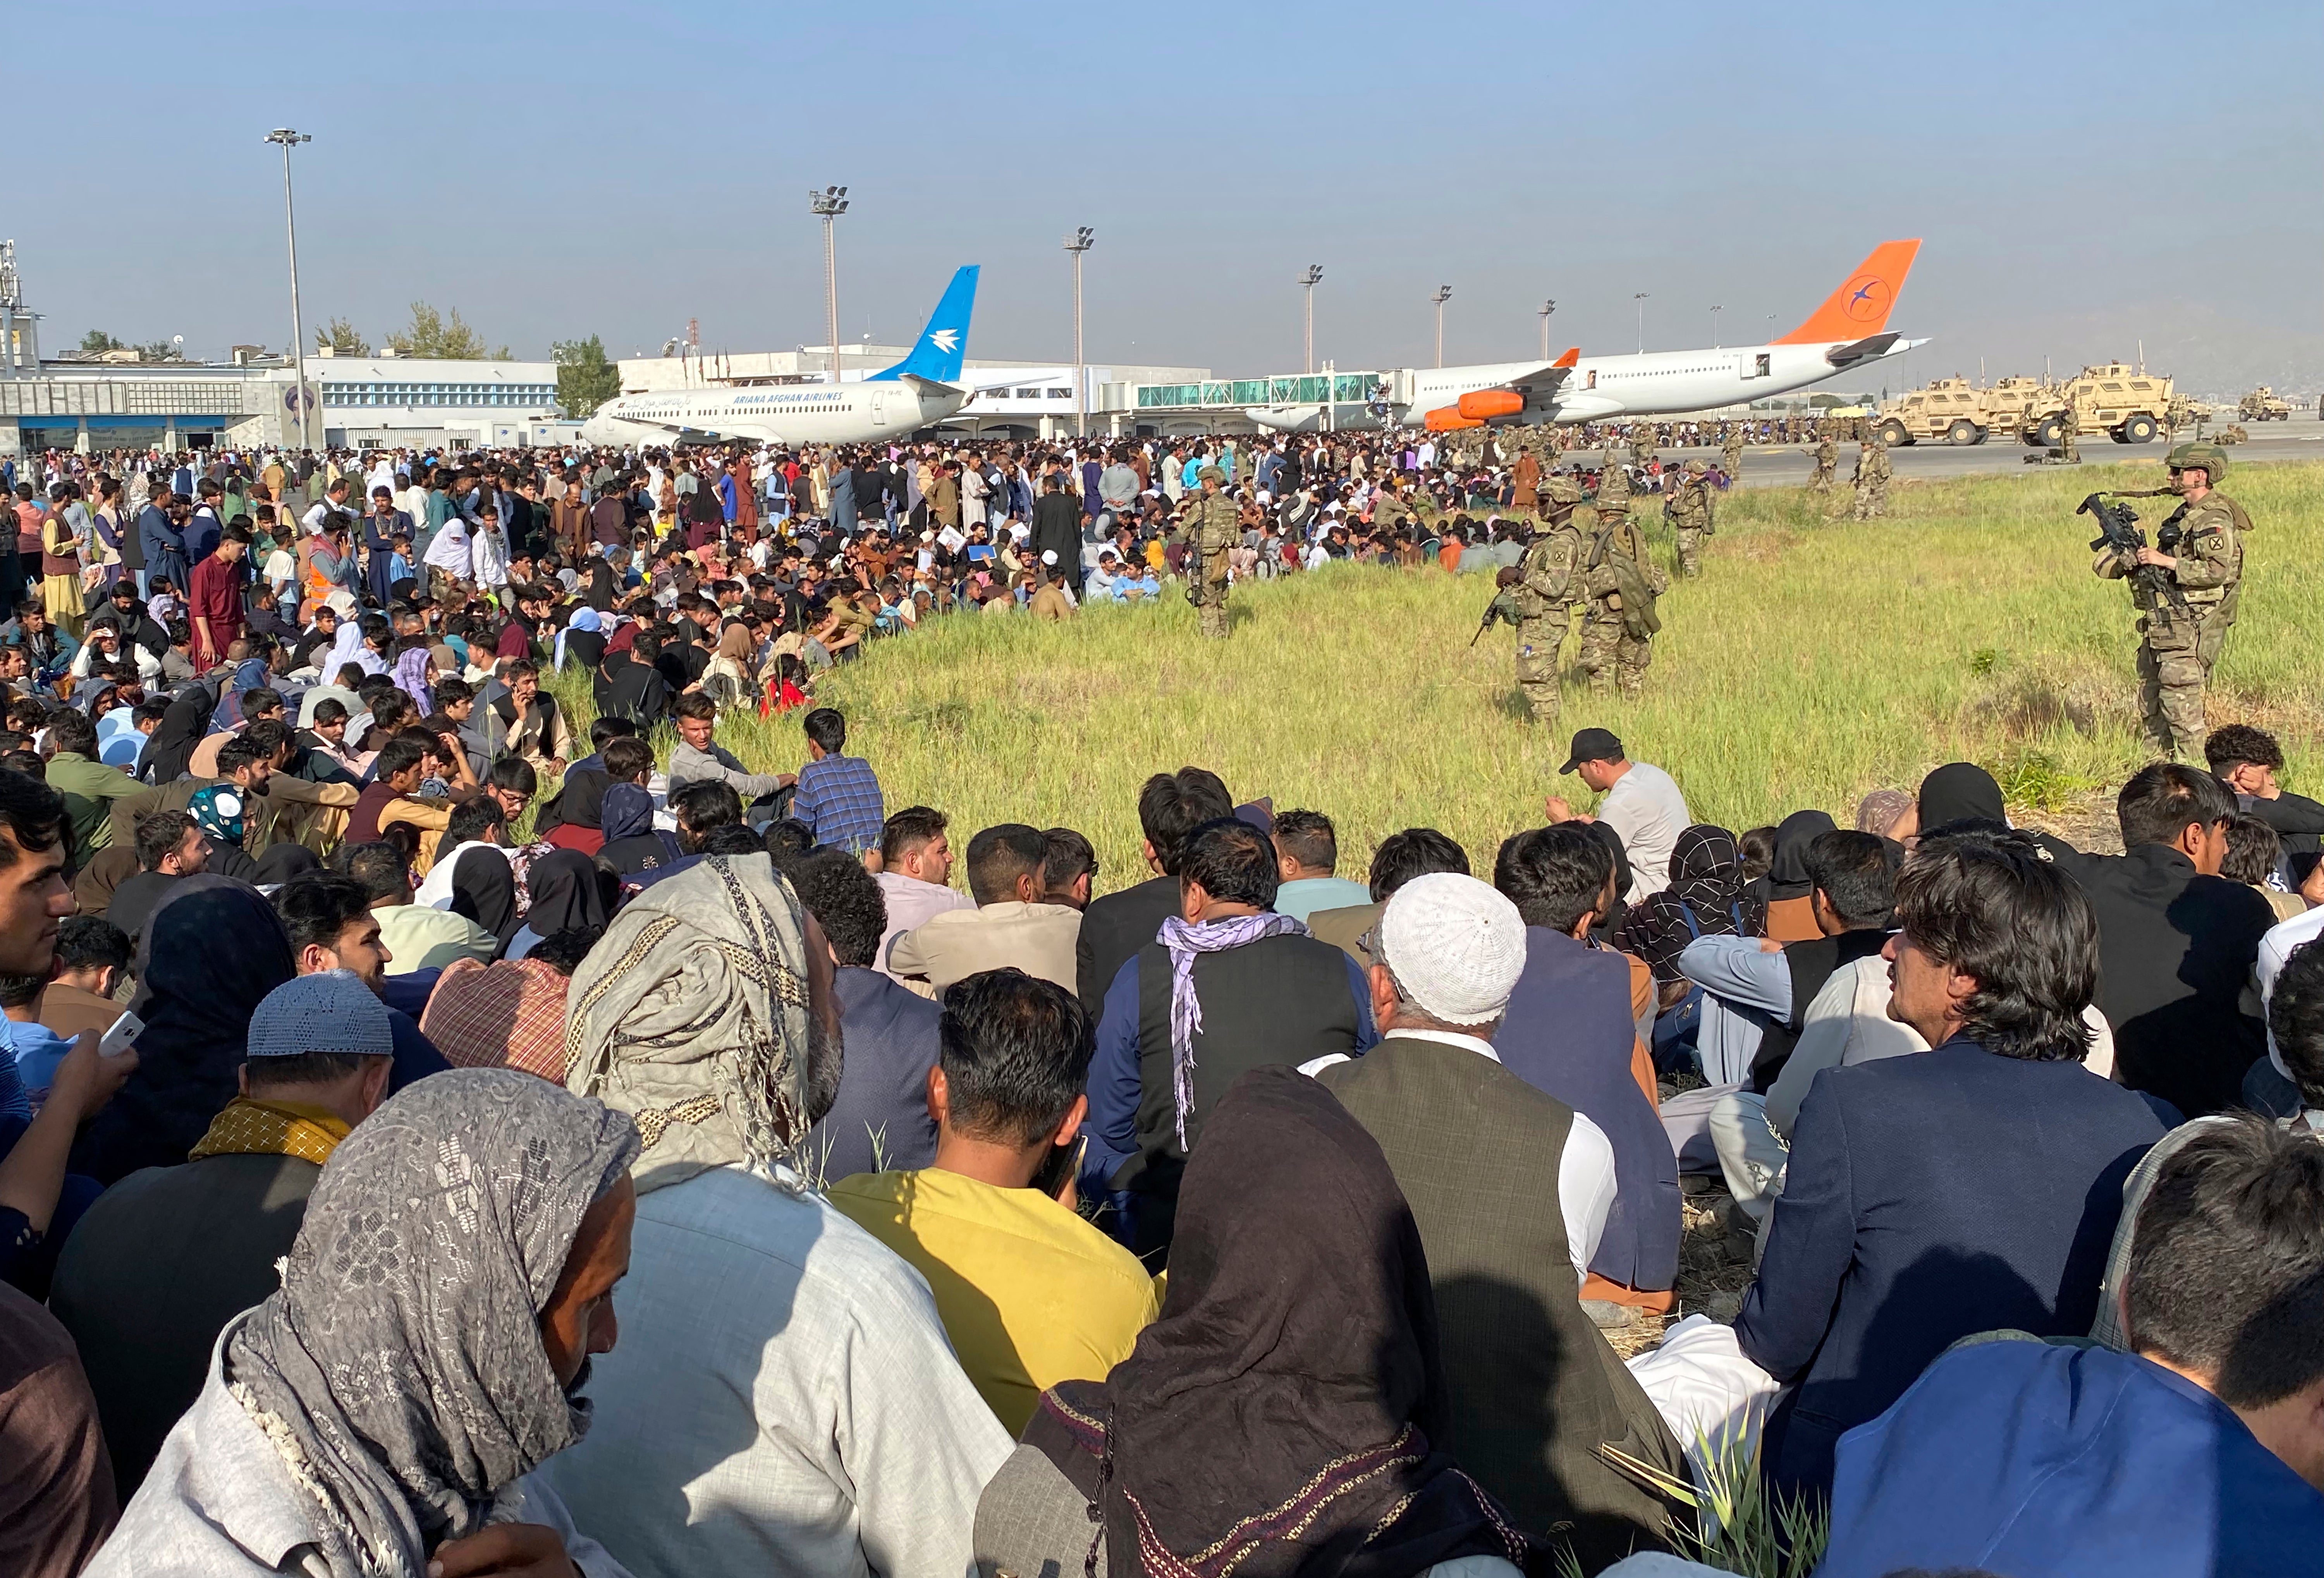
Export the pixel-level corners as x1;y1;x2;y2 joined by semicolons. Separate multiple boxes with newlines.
888;823;1081;997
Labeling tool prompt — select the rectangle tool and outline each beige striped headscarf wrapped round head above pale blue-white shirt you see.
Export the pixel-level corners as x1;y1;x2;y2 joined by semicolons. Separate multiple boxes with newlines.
565;855;818;1195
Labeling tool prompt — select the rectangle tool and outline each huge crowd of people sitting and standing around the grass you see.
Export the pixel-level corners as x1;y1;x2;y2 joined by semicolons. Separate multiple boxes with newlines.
0;437;2324;1578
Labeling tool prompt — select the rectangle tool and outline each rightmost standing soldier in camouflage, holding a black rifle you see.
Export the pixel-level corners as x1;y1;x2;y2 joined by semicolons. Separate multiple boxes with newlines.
2092;444;2243;760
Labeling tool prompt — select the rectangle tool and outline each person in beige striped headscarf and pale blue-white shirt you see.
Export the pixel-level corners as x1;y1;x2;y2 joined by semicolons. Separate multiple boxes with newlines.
548;860;1009;1578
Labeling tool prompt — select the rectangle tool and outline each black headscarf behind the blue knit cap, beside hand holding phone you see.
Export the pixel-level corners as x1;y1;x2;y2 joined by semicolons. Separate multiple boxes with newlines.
72;876;297;1185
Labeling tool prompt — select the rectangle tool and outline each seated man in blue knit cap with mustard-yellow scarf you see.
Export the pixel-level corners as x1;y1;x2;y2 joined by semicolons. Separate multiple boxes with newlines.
49;972;395;1497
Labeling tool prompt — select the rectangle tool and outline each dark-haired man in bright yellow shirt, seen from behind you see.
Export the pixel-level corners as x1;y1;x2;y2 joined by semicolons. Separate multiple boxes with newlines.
830;971;1157;1436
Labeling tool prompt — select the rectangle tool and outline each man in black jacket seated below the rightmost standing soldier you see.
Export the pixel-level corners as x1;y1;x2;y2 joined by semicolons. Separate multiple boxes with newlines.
2036;762;2275;1118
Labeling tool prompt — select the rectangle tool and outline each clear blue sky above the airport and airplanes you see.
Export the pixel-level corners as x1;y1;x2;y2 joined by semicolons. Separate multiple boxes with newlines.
18;0;2324;383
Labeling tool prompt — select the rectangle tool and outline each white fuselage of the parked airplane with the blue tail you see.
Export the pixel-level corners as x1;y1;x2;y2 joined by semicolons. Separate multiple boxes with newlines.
581;379;969;444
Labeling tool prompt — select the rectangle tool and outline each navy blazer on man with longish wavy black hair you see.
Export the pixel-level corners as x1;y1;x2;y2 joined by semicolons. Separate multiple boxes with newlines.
1736;1037;2164;1490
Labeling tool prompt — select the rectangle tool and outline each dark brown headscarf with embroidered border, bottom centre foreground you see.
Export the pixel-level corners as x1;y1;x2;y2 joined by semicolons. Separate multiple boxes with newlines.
1025;1067;1527;1578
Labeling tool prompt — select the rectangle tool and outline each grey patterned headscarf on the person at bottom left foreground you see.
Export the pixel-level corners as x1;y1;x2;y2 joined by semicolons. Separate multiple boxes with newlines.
225;1069;637;1578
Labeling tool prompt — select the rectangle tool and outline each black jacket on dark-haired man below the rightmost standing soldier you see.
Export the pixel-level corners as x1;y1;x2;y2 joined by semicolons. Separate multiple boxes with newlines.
2038;835;2275;1118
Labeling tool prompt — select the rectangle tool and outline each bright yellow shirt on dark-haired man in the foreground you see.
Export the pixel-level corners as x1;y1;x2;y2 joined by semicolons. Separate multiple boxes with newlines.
830;1167;1160;1436
